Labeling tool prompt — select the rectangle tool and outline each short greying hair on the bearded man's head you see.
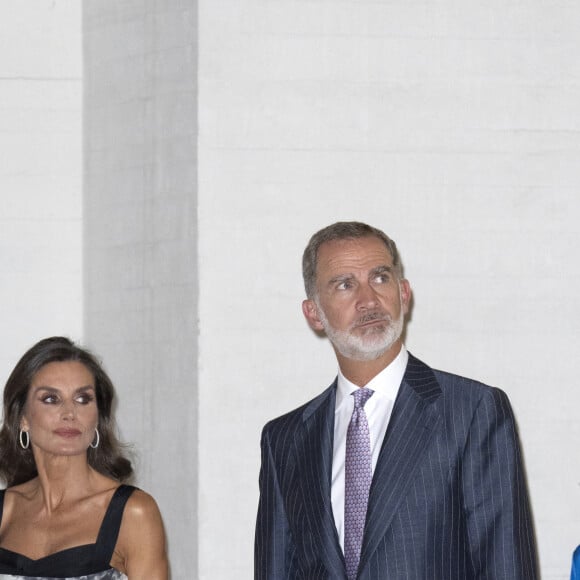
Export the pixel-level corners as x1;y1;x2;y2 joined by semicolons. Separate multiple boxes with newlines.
302;222;403;299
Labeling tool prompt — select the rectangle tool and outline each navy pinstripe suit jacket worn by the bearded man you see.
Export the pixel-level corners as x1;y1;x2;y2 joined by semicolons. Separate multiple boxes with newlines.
254;355;538;580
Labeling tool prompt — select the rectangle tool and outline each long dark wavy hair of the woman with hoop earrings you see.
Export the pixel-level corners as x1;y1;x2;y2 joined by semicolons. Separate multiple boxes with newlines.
0;336;133;487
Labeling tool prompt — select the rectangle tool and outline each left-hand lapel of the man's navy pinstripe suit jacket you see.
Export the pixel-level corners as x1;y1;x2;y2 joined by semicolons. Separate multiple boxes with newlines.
296;381;346;580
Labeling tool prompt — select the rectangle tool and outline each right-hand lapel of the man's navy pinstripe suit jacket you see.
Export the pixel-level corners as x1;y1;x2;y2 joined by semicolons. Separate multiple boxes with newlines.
360;354;441;571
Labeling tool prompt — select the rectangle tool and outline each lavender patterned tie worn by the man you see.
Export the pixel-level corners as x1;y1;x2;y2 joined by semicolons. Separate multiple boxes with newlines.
344;388;374;580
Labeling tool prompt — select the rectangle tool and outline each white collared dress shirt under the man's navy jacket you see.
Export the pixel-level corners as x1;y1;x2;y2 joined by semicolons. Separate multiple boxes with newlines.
330;346;409;550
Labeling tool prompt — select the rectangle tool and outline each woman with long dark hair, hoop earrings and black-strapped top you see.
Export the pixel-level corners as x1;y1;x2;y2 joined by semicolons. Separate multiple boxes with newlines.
0;337;168;580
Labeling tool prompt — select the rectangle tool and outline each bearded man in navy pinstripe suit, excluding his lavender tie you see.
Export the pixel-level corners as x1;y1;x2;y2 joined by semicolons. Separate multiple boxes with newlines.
255;222;538;580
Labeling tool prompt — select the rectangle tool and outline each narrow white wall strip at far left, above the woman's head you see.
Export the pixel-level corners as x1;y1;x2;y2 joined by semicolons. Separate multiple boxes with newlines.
0;0;83;385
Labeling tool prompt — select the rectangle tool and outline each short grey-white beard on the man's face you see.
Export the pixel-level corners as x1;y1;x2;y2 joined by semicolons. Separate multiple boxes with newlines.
315;300;405;361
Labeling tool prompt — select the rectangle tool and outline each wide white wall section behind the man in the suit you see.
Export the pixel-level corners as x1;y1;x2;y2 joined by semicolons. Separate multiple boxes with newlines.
199;0;580;580
